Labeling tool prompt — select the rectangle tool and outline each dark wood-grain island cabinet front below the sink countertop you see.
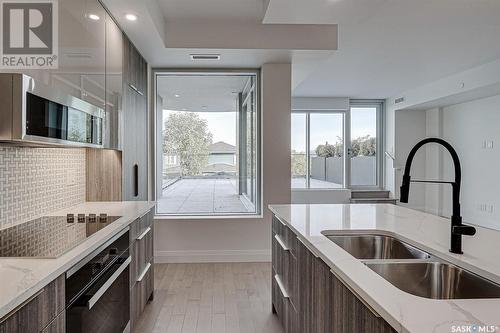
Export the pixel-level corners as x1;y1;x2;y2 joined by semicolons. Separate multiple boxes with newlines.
272;216;395;333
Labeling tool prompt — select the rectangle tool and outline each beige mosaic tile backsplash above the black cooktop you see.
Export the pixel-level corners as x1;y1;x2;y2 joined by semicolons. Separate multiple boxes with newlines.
0;146;85;228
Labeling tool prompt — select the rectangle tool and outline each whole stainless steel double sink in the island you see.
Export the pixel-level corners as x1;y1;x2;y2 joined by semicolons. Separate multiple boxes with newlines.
323;231;500;299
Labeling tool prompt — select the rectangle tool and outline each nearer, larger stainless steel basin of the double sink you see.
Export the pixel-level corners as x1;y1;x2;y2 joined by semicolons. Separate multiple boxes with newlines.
365;262;500;299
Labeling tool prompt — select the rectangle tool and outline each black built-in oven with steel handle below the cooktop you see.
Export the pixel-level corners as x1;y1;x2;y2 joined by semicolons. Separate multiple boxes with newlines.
66;229;131;333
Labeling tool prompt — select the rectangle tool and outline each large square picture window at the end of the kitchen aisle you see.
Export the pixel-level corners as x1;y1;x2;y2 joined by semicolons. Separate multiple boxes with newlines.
155;72;261;216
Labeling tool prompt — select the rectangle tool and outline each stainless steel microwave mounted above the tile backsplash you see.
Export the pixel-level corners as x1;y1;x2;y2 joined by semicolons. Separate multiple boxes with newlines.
0;74;105;148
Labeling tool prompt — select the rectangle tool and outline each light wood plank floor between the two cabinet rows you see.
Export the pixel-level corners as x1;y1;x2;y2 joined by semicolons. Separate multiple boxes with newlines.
134;263;283;333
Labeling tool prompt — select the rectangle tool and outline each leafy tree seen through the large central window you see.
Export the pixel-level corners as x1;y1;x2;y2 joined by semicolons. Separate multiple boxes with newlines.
163;112;212;176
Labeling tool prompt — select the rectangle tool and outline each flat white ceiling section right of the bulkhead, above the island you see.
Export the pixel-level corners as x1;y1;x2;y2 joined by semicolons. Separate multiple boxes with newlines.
266;0;500;98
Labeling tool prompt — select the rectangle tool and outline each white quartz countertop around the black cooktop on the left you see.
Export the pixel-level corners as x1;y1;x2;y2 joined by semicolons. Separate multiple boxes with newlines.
0;201;154;318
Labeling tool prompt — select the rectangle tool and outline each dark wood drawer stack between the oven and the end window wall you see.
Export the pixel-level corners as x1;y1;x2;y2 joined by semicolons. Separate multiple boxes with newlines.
130;210;154;328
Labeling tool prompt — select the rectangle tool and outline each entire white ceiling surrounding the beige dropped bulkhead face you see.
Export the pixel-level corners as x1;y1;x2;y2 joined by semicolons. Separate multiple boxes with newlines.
104;0;500;98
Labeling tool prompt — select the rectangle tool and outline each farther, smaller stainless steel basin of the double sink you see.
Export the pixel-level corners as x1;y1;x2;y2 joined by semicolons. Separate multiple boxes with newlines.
325;234;430;260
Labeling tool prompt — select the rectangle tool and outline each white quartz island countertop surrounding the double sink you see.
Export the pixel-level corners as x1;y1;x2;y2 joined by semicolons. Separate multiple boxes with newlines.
269;204;500;333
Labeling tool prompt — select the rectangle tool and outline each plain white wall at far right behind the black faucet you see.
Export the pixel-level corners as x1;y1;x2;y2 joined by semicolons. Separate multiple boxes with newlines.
434;95;500;229
